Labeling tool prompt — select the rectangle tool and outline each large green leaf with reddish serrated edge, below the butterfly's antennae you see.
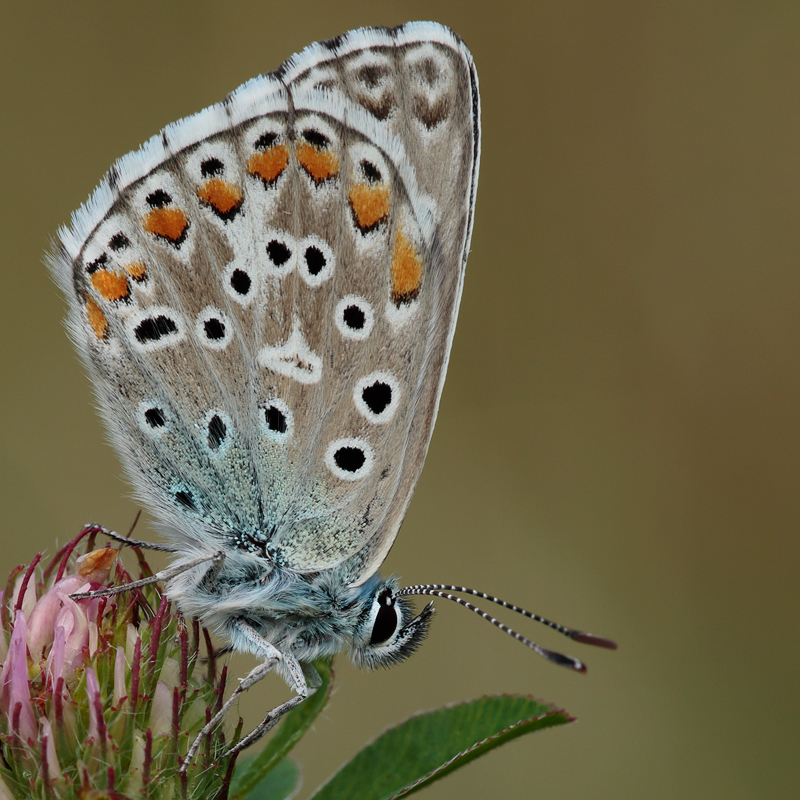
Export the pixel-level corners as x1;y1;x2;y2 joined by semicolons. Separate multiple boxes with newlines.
312;695;573;800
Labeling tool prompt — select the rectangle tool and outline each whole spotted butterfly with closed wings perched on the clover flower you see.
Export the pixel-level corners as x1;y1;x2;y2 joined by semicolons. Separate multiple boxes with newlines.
50;22;611;763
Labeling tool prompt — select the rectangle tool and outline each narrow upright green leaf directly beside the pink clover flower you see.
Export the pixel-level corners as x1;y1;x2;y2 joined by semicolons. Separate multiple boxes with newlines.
229;661;333;800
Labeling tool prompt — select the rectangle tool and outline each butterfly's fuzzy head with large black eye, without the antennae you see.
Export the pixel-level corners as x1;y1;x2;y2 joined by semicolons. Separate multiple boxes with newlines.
351;578;433;669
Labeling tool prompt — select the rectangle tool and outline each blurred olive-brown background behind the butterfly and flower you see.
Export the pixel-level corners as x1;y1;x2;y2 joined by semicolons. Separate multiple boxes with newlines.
0;0;800;800
